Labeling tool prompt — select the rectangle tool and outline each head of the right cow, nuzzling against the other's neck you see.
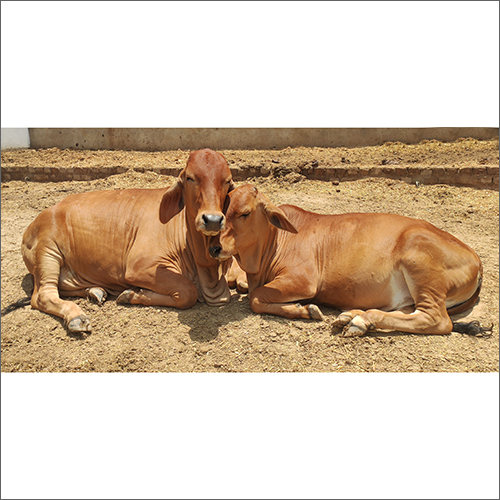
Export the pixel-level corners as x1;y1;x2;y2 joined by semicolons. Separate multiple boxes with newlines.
210;184;297;272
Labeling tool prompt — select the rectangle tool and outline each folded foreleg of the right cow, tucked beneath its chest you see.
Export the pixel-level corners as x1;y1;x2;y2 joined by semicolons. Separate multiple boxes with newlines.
249;280;324;320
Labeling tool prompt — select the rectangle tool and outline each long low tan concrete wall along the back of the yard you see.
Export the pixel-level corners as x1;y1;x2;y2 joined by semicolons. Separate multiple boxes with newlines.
29;127;498;151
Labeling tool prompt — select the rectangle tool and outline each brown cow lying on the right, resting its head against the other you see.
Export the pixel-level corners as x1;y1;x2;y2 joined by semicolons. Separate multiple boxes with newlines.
211;184;482;337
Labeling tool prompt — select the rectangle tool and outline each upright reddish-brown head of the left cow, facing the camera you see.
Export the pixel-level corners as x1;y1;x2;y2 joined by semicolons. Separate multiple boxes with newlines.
160;149;233;236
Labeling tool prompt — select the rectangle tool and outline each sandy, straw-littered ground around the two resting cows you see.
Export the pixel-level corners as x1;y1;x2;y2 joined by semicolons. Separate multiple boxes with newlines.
1;140;499;372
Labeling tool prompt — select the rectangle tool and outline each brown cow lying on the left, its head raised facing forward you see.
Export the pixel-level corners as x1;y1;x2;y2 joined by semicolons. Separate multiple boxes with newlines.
22;149;233;332
